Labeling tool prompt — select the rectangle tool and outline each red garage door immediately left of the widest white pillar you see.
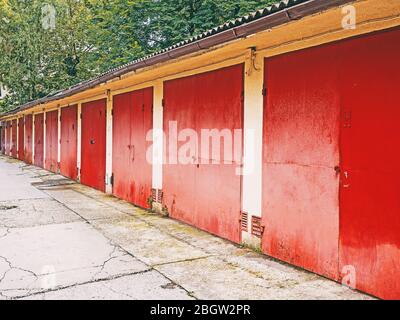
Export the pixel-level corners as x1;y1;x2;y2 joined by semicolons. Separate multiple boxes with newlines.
163;65;243;242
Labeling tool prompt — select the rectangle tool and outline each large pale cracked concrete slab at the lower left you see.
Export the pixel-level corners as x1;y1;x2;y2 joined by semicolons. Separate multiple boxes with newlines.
0;222;149;298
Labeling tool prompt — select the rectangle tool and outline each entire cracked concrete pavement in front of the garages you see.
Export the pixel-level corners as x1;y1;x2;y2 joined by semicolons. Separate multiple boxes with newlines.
0;156;370;300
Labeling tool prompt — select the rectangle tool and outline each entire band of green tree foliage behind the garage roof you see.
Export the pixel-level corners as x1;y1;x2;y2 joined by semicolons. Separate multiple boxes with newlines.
0;0;276;111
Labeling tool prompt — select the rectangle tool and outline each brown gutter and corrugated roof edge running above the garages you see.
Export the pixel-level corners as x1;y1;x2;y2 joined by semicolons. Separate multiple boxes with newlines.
0;0;355;117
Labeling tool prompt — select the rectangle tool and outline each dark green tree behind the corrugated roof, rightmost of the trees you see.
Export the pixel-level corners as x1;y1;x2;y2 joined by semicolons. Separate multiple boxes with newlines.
123;0;277;53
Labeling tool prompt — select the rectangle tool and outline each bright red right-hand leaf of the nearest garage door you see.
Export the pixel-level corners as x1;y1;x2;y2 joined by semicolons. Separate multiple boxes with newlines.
340;30;400;299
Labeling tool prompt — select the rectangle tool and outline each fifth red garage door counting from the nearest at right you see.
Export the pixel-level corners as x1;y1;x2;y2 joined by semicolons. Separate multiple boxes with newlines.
60;105;78;180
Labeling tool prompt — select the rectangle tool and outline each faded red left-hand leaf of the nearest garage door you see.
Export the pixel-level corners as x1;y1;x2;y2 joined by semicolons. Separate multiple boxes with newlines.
262;46;340;279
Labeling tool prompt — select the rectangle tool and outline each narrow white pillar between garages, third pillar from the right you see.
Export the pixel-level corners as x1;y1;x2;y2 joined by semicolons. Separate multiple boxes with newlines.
106;90;113;194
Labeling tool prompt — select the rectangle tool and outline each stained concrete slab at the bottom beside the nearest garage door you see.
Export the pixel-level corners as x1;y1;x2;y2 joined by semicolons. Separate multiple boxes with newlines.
155;257;372;300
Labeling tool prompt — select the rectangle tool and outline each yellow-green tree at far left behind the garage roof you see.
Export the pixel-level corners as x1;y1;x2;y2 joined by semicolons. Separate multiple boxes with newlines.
0;0;99;108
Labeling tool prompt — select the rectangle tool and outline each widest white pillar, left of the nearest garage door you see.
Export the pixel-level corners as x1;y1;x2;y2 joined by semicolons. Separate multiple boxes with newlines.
242;51;264;245
